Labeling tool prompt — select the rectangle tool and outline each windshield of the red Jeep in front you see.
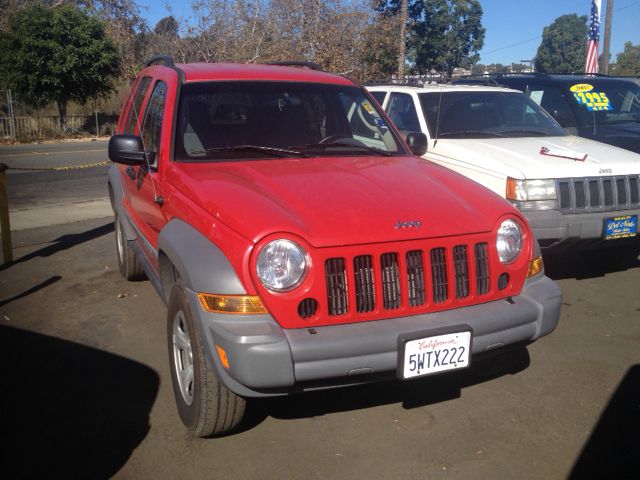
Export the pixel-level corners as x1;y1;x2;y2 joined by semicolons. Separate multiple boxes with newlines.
175;81;404;161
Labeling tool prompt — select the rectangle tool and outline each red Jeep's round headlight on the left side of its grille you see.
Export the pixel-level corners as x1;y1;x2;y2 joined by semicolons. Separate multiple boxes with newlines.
256;240;307;292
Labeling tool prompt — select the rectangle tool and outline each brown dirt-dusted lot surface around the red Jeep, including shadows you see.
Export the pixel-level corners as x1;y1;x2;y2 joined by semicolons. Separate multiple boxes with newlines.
0;218;640;480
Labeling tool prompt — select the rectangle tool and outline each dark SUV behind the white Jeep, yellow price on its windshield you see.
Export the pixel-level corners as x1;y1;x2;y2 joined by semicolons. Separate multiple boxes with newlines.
462;73;640;153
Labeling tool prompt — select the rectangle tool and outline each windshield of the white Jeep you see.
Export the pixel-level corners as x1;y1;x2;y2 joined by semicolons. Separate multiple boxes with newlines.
420;91;567;138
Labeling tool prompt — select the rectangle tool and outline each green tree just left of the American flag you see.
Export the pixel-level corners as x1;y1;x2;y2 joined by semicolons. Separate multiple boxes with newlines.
535;13;587;73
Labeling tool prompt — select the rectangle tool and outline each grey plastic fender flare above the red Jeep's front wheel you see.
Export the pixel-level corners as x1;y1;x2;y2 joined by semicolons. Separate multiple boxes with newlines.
158;218;247;295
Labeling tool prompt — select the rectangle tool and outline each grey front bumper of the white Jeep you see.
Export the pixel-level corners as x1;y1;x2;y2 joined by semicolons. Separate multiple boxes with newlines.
522;209;640;243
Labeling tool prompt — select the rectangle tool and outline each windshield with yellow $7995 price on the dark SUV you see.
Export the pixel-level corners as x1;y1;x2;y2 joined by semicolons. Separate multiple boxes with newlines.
569;81;640;126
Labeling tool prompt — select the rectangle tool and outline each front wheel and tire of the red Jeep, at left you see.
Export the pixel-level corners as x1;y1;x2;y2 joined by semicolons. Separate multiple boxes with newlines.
167;285;246;437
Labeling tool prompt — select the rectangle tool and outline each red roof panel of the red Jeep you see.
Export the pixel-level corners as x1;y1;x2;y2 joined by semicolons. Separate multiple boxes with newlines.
151;63;353;85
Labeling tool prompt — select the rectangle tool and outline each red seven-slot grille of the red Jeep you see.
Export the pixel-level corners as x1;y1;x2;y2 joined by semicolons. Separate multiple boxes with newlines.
325;242;491;316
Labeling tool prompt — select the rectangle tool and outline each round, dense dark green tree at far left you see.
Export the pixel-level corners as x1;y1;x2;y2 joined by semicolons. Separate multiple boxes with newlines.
0;4;118;125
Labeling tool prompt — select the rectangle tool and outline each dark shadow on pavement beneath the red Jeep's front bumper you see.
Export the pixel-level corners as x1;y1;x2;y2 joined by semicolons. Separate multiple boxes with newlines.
240;347;530;431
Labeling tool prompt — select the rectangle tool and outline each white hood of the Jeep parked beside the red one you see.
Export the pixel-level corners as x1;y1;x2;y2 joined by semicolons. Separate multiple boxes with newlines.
425;136;640;179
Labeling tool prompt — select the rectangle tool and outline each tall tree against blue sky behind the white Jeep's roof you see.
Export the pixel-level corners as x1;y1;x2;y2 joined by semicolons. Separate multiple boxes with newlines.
374;0;485;76
